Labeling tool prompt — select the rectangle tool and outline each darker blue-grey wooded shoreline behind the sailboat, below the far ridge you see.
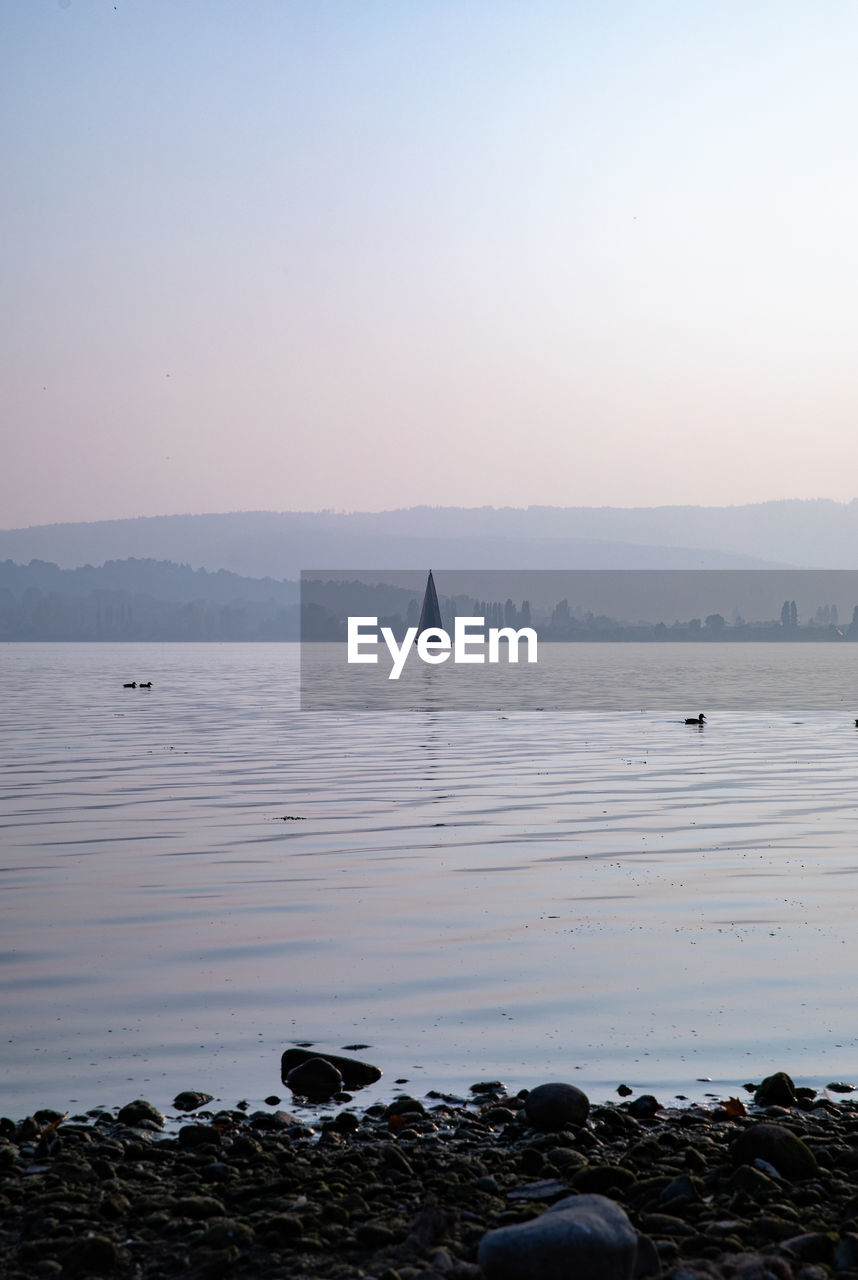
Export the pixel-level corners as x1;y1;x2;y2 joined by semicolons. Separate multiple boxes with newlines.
0;559;858;643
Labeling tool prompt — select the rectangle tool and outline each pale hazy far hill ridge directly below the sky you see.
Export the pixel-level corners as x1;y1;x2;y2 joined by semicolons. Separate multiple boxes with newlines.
0;499;858;581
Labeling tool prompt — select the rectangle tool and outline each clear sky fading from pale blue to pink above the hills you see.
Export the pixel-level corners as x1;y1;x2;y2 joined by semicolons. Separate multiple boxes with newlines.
0;0;858;529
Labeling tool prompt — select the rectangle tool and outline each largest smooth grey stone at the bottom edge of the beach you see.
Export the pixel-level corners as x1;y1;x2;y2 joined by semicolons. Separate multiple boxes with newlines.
478;1196;660;1280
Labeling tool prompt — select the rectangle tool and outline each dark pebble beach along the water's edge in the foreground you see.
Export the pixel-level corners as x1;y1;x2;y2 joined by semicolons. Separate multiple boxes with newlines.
0;1073;858;1280
